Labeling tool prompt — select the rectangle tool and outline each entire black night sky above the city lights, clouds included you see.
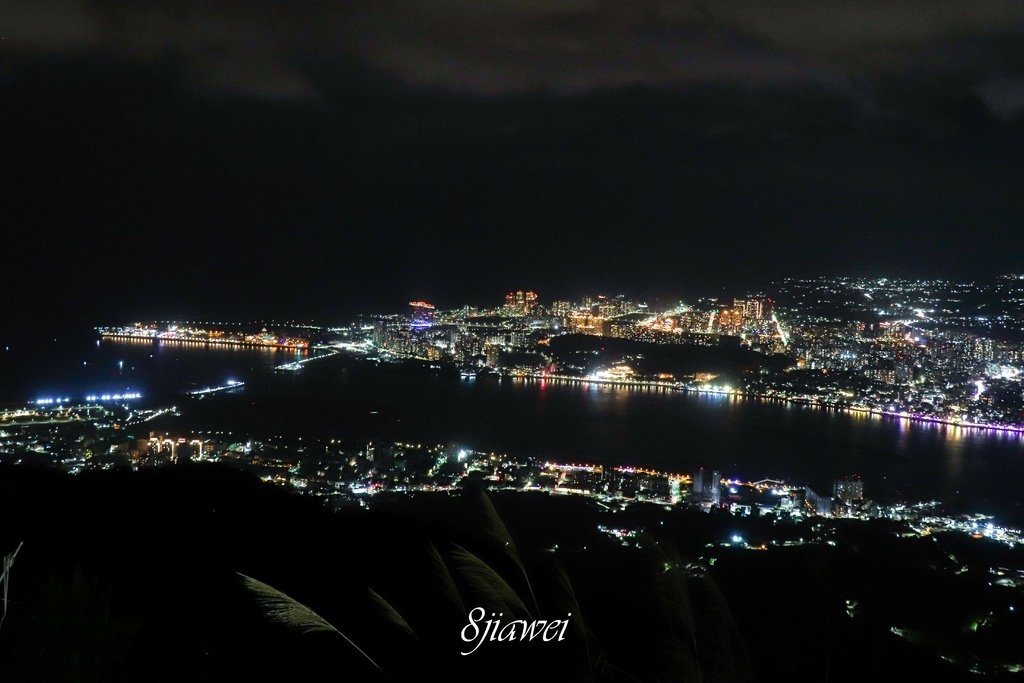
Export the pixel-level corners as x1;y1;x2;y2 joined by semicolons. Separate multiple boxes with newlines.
6;0;1024;325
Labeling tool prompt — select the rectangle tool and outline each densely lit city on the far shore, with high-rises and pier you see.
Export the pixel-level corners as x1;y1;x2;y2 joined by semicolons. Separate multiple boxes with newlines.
100;275;1024;431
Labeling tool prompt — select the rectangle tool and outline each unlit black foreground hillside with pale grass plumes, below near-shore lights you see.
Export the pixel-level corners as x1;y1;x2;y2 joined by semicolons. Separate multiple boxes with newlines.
0;465;995;681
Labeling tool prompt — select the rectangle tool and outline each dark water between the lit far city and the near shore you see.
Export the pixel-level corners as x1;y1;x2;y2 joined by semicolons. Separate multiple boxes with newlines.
0;335;1024;521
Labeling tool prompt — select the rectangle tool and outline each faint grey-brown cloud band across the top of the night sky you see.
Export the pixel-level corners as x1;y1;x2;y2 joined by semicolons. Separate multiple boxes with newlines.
6;0;1024;112
